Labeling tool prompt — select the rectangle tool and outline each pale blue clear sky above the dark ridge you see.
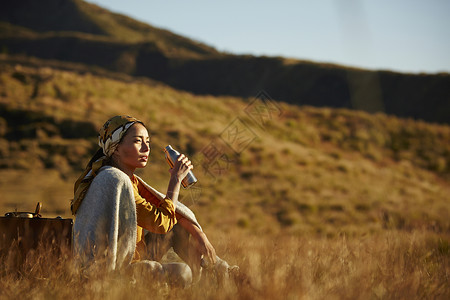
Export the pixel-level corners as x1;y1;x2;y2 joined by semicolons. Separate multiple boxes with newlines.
88;0;450;73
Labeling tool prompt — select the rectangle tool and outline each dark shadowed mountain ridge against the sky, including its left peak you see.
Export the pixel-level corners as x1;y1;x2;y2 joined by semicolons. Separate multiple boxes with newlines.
0;0;450;124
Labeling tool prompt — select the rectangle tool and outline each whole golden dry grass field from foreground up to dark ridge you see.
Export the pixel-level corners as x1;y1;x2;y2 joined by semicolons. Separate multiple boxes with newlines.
0;57;450;299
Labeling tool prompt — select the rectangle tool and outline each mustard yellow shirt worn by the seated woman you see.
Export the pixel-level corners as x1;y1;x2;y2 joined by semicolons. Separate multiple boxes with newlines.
131;176;177;259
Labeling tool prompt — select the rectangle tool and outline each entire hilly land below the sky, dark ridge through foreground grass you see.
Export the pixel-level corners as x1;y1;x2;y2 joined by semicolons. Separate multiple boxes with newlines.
0;0;450;300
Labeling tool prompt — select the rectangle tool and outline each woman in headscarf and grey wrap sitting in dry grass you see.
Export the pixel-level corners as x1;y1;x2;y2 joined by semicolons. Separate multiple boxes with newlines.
71;116;234;282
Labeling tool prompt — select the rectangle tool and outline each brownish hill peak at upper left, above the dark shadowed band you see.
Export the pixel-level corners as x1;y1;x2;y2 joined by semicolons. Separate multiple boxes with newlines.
0;0;218;57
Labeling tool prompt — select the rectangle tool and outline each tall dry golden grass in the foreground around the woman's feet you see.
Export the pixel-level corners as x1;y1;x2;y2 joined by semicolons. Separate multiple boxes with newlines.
0;231;450;299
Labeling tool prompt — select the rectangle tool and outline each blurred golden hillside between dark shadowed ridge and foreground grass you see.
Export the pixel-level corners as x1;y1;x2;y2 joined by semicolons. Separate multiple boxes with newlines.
0;56;450;236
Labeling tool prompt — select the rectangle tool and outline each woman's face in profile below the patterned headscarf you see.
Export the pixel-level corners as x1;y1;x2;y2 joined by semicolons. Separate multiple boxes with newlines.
113;123;150;175
